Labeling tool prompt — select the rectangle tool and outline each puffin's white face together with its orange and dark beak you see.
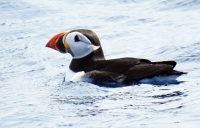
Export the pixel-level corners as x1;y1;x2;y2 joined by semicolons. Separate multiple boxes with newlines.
46;31;100;59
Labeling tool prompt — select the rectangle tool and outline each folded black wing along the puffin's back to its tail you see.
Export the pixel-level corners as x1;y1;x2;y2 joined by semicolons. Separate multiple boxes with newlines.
85;58;183;83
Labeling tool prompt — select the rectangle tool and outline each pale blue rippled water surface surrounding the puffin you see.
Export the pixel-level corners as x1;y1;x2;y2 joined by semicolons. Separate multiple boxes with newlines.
0;0;200;128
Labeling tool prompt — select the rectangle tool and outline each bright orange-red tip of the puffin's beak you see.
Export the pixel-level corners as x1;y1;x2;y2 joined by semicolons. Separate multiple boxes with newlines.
46;32;65;50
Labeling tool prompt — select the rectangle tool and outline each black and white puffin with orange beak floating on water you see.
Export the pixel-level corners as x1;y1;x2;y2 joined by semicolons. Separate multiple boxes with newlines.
46;29;187;84
